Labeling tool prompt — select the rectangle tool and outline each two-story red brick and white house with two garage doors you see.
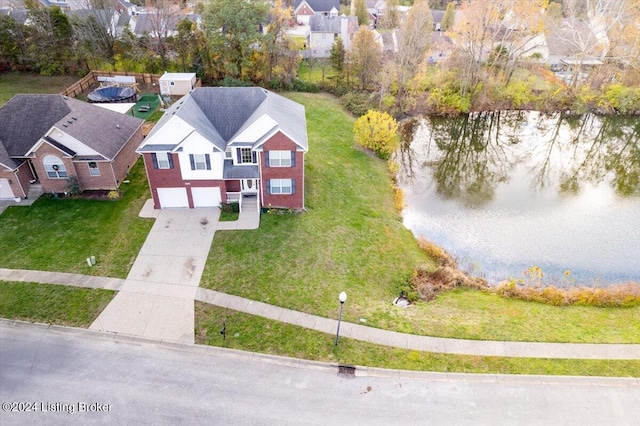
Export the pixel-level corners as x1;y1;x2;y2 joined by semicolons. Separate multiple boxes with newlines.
137;87;309;209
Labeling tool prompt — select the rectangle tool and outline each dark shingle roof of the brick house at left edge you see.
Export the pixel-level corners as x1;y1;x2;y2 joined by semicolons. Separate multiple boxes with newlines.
0;95;143;170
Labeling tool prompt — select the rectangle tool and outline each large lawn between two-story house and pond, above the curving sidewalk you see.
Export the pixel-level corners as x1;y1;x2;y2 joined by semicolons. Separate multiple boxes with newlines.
201;94;640;343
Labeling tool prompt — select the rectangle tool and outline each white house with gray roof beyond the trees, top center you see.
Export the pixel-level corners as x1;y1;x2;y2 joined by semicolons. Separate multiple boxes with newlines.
307;15;358;58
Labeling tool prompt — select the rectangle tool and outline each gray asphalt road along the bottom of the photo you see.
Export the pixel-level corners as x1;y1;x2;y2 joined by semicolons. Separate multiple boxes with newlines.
0;321;640;426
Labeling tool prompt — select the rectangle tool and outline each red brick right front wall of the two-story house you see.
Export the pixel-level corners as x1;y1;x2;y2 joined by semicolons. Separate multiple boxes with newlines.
260;132;304;210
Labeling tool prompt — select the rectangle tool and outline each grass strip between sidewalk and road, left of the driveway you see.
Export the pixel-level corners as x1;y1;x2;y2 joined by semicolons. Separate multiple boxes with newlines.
0;281;116;327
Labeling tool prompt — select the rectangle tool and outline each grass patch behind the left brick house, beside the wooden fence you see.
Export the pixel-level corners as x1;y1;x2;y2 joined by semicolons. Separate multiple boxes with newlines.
0;72;78;107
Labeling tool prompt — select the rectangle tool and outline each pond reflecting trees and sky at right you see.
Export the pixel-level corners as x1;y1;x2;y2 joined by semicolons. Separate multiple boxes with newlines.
396;111;640;285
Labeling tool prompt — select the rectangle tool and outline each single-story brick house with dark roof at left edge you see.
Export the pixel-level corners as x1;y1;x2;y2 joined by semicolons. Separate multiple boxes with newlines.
0;95;143;198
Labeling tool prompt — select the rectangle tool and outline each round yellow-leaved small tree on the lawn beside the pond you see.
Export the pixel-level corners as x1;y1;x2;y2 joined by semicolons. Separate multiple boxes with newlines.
353;110;400;160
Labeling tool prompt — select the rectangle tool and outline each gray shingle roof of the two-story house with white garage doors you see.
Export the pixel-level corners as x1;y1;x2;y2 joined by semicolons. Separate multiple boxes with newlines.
139;87;309;152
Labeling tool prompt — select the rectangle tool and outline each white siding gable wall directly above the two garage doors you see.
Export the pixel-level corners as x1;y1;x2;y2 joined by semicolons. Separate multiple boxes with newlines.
178;132;224;180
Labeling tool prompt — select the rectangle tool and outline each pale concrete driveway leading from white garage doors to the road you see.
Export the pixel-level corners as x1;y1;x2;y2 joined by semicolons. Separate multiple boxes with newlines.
90;206;220;343
